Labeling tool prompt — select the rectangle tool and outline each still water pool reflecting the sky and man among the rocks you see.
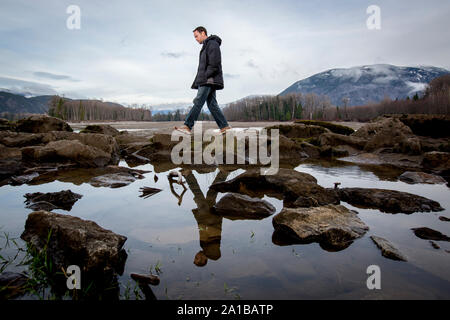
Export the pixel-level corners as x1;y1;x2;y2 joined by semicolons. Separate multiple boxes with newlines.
0;161;450;299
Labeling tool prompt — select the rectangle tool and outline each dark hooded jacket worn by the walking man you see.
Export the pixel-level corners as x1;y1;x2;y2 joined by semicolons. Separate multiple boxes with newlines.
191;34;223;90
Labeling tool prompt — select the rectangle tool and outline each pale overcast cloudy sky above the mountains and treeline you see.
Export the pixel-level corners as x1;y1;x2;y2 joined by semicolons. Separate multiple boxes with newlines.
0;0;450;109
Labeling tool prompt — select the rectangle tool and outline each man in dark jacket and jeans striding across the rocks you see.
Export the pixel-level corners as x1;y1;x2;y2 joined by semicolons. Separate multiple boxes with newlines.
175;27;231;134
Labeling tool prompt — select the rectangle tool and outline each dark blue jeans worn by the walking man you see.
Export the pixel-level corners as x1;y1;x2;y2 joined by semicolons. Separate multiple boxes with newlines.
184;86;228;129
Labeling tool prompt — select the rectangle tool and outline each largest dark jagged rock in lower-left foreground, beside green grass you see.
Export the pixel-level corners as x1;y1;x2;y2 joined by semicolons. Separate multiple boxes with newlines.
20;210;127;275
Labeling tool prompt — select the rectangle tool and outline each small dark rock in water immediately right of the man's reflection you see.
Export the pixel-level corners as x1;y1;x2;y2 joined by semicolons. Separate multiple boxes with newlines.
213;193;276;220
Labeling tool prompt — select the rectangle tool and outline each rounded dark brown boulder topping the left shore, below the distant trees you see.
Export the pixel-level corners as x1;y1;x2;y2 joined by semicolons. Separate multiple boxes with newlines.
16;114;73;133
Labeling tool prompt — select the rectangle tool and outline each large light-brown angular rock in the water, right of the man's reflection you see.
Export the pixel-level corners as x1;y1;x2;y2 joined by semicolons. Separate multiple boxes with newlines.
272;205;369;251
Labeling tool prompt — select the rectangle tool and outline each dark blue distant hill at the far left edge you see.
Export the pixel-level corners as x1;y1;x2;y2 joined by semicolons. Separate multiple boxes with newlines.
0;91;52;113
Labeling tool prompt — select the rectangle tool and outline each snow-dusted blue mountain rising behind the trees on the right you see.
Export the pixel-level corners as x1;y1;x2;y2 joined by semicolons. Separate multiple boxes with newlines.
280;64;450;106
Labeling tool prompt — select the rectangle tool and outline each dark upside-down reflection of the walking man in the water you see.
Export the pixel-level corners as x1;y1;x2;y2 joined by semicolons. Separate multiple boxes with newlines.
182;169;228;267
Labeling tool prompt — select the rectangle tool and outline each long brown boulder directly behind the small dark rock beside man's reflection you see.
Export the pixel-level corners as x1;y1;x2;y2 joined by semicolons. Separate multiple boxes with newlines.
210;168;339;206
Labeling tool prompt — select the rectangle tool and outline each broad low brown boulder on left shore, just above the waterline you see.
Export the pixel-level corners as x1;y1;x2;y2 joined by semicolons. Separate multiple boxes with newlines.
22;140;116;167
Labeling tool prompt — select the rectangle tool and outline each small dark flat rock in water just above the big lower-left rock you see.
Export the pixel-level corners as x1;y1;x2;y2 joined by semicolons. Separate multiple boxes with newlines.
24;190;83;211
